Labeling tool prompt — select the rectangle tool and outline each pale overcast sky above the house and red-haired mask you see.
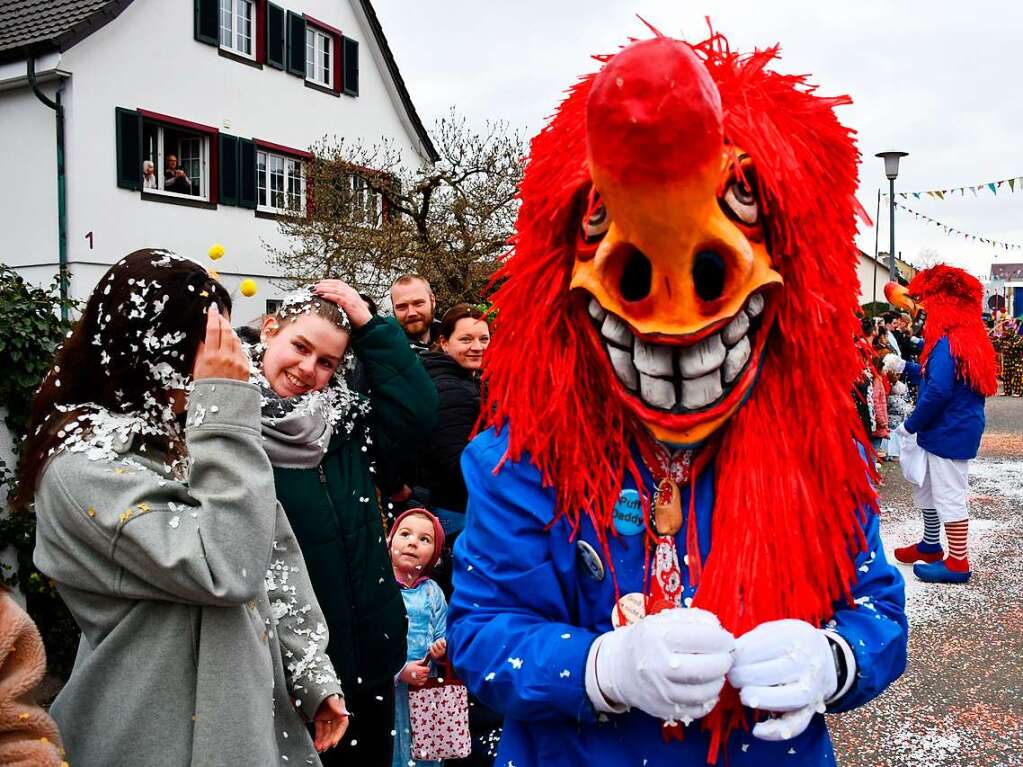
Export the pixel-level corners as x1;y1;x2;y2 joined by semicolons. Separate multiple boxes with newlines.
373;0;1023;274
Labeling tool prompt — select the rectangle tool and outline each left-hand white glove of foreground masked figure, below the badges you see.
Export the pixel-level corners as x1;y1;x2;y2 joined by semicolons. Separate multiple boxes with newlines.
586;607;736;725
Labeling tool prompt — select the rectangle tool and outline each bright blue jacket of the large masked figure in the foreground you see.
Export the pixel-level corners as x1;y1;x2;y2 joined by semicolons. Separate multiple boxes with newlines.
448;431;907;767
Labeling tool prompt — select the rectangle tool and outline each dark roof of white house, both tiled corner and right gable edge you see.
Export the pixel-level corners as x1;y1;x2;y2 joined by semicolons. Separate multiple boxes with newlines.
0;0;440;162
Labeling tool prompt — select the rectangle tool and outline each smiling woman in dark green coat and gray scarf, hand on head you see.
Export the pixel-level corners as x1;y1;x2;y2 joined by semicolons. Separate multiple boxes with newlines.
247;280;437;766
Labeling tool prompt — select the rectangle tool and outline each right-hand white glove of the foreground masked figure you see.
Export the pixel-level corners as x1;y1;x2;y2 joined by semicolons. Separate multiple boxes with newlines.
728;620;855;740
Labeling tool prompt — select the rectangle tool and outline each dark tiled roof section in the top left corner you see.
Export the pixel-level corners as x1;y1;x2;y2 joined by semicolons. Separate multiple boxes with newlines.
0;0;131;62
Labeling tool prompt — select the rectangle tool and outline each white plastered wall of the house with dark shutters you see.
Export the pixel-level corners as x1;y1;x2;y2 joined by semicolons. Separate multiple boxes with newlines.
0;0;419;321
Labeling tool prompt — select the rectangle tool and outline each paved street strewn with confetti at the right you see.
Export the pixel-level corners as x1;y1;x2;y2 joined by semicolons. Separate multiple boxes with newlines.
831;397;1023;767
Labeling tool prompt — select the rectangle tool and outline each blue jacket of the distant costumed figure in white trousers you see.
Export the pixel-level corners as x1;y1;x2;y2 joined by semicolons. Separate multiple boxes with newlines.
903;335;984;460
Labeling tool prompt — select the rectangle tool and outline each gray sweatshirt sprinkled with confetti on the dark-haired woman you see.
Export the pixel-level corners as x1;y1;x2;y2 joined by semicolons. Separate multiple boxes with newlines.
35;379;341;767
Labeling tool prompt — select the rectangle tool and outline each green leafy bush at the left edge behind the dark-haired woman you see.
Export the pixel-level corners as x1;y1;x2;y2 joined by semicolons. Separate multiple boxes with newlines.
0;264;79;679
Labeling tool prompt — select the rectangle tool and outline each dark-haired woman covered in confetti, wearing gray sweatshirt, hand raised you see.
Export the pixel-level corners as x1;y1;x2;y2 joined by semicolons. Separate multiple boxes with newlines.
17;249;348;767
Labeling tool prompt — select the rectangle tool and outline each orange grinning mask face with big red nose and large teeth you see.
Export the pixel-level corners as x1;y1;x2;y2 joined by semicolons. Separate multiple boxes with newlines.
571;38;782;445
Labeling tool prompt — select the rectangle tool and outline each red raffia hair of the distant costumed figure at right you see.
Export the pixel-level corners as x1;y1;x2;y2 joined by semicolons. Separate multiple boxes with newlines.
908;264;998;397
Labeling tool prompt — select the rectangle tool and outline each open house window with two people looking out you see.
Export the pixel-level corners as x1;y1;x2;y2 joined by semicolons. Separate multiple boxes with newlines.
142;121;210;200
